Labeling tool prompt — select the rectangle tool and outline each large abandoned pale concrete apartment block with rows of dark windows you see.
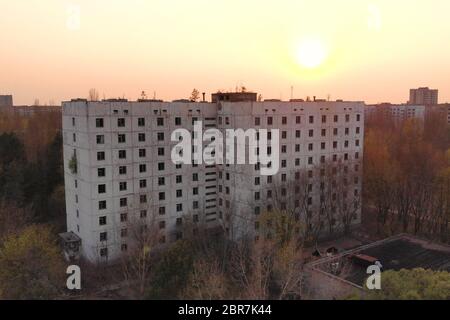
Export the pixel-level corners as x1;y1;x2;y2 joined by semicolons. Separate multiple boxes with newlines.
63;100;364;262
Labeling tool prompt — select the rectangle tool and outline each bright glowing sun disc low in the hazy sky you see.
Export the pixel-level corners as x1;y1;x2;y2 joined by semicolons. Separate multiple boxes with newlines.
297;39;328;69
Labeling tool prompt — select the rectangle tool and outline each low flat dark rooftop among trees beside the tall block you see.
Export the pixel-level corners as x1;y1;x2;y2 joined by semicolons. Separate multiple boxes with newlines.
310;234;450;286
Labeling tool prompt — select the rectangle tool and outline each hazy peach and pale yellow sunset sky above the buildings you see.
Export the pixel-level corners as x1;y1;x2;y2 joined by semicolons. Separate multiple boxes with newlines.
0;0;450;104
